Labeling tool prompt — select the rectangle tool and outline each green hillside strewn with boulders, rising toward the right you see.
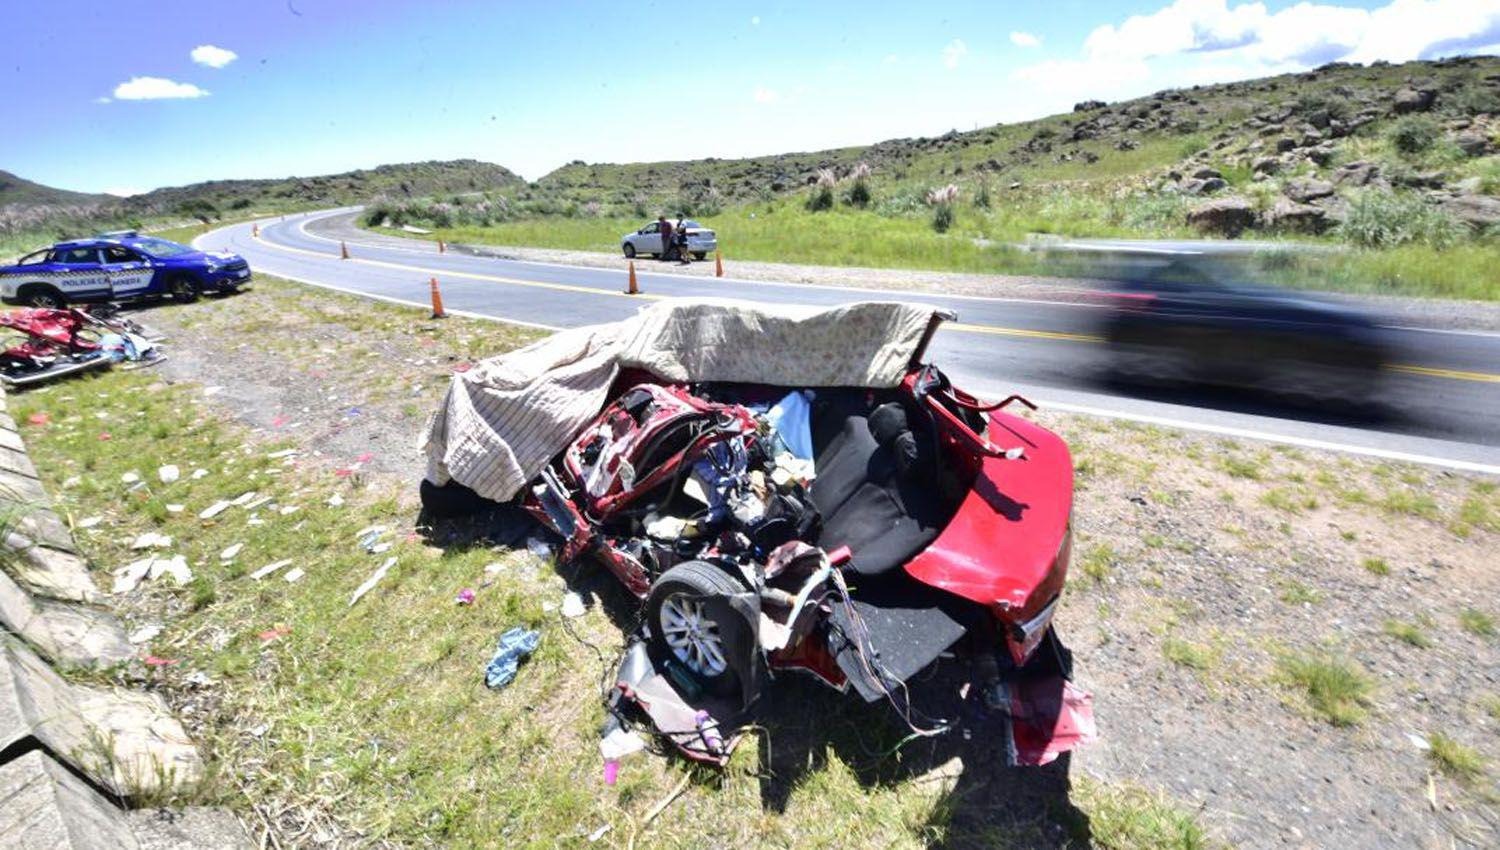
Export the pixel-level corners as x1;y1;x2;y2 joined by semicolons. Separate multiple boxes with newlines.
533;57;1500;232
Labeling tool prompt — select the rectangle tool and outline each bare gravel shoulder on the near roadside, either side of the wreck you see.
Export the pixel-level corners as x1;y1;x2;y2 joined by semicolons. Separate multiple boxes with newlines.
90;280;1500;849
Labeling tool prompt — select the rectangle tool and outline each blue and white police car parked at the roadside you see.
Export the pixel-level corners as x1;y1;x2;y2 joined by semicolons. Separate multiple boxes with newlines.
0;231;251;307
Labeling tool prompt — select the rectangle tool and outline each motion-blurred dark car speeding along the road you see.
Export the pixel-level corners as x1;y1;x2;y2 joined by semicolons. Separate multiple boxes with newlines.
1103;253;1391;405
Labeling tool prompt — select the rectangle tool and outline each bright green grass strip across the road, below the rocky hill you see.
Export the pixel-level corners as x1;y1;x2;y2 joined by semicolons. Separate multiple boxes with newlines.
363;195;1500;301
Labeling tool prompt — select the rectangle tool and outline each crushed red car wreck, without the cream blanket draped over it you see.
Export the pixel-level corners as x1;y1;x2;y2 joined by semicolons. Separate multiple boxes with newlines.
429;302;1094;765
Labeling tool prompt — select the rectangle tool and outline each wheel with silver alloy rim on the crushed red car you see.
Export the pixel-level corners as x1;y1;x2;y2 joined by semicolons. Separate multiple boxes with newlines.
647;561;749;694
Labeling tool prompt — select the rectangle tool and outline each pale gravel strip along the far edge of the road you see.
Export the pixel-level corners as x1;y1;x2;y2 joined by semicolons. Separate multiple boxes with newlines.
308;213;1500;331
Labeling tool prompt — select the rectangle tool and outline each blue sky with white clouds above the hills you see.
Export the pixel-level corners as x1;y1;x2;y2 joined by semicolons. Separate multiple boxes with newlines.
0;0;1500;192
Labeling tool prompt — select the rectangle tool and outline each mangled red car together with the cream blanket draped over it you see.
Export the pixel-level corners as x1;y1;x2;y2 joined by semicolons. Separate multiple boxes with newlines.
423;301;1095;765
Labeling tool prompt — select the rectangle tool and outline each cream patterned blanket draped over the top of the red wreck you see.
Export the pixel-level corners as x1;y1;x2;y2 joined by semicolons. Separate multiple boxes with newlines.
423;300;936;501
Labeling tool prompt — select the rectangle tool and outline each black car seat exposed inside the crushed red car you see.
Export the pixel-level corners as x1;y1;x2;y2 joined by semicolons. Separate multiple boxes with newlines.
809;399;945;577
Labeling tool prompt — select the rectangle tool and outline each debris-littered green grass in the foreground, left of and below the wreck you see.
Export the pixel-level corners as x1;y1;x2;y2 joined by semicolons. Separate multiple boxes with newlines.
11;280;1209;849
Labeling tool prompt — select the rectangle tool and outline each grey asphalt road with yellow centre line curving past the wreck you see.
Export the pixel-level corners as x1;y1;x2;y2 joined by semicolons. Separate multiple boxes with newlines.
195;210;1500;474
